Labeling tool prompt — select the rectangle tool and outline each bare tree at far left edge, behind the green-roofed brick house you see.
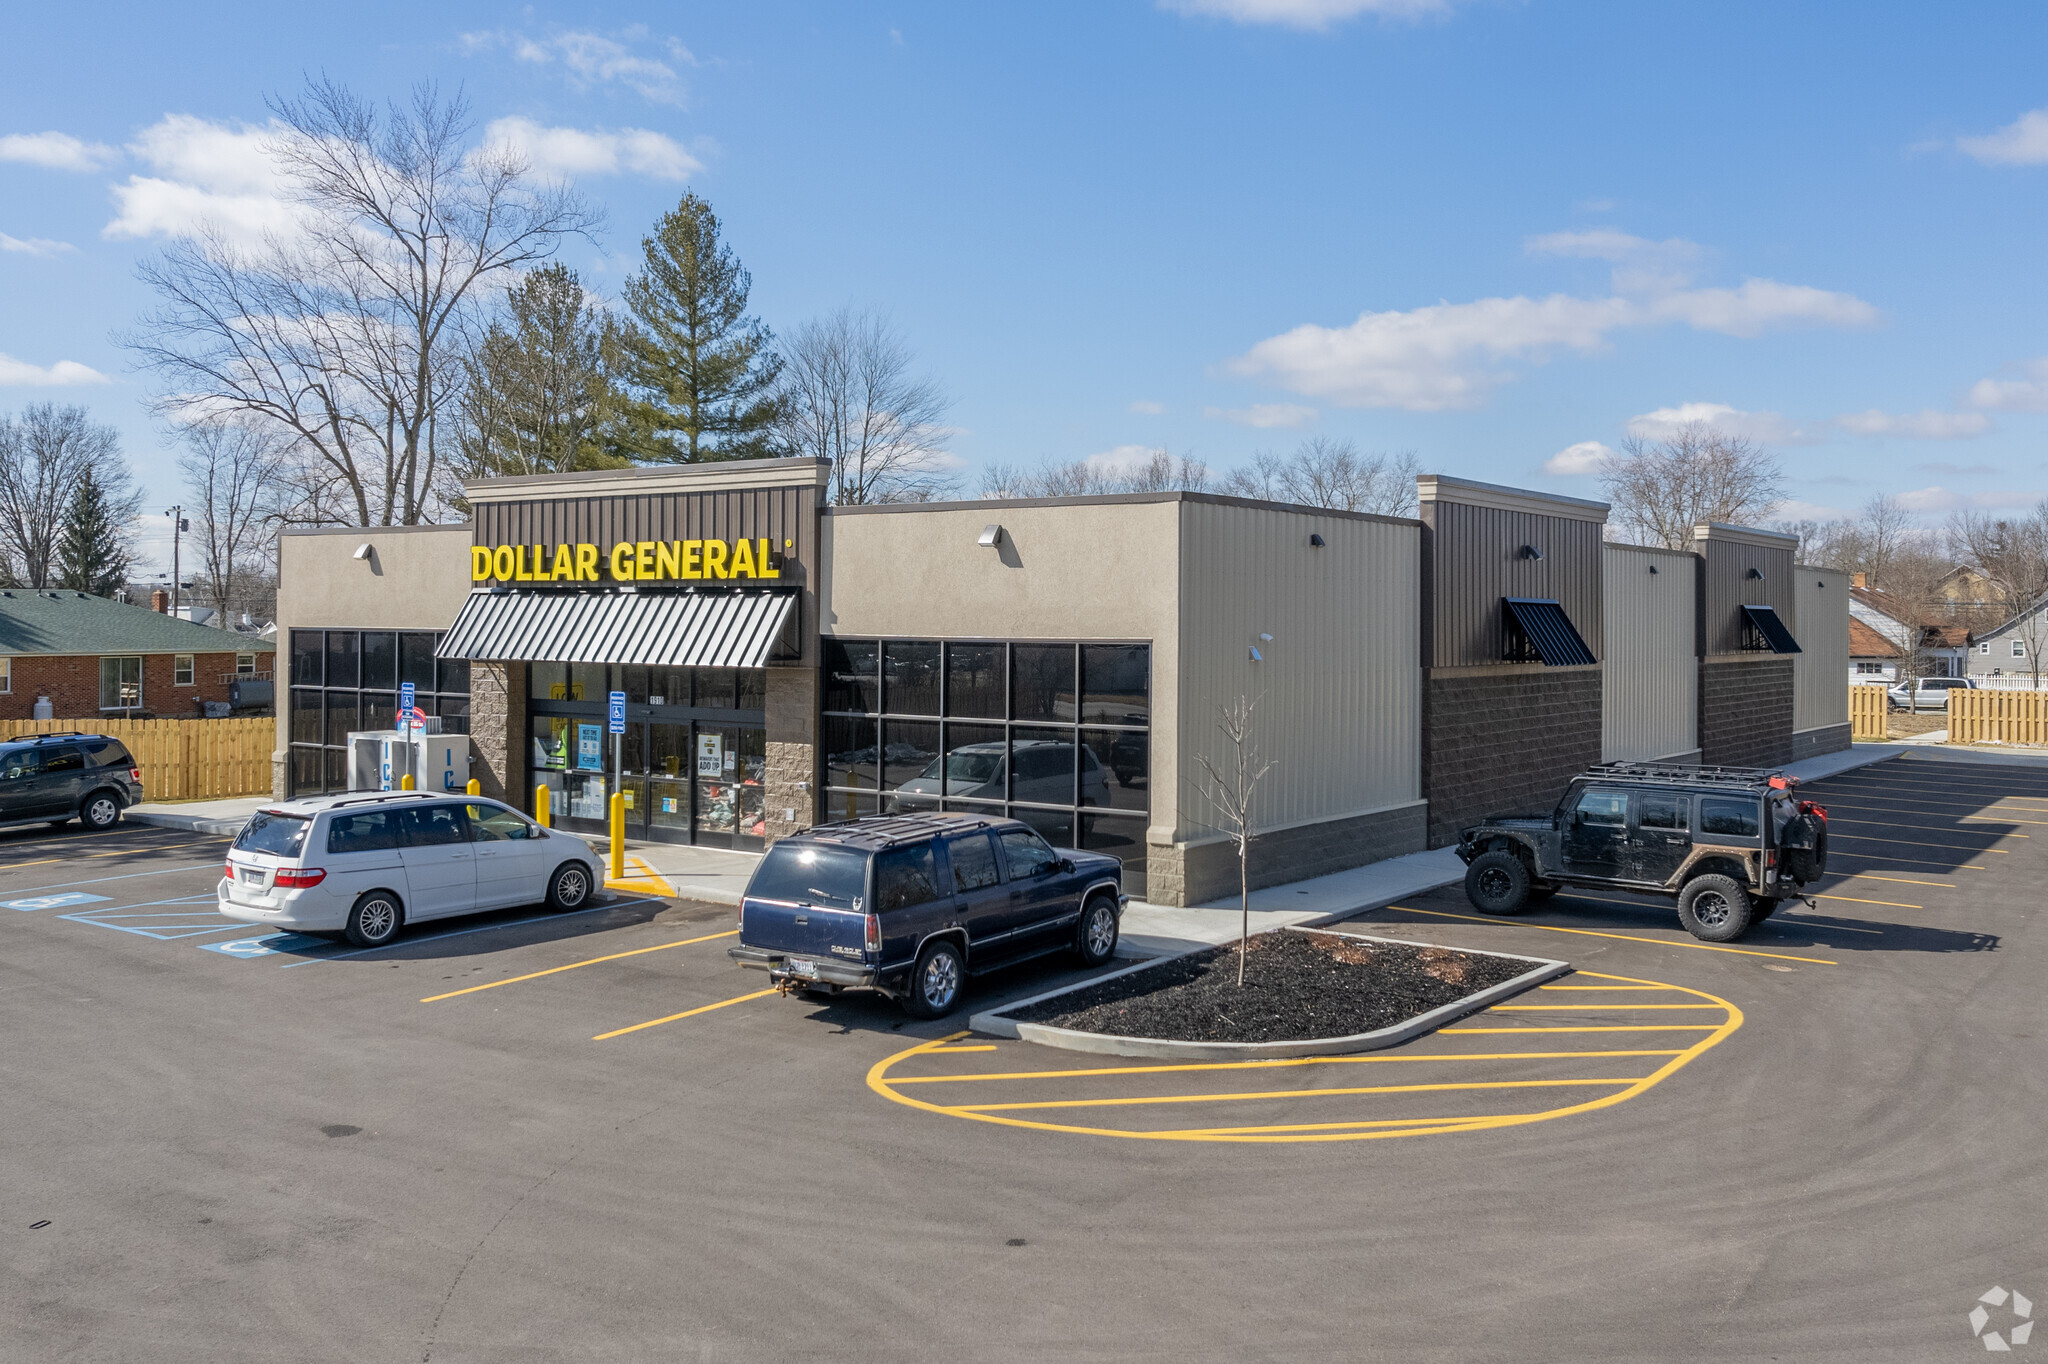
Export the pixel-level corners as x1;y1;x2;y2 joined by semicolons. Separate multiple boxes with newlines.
0;403;141;588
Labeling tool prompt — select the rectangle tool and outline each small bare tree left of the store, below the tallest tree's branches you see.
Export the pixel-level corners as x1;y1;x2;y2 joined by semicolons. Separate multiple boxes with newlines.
178;418;289;625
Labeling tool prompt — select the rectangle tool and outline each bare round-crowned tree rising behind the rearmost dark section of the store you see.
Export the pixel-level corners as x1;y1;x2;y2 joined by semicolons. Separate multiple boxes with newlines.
1599;422;1784;549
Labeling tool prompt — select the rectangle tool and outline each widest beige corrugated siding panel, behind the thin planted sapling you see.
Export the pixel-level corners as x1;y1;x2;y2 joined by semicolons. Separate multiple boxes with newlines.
1179;502;1421;838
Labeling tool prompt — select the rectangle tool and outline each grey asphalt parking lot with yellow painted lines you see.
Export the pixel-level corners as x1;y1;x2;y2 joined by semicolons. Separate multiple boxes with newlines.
0;756;2048;1362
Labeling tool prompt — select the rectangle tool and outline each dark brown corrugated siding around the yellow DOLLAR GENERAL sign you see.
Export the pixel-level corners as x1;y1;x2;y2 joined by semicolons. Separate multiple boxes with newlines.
473;485;819;666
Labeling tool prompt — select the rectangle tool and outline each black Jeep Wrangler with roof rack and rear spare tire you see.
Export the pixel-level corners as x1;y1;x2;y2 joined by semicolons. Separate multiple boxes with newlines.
1458;762;1827;942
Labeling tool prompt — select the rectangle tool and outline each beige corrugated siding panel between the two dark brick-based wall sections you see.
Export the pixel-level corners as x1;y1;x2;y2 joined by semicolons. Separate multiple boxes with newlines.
1599;545;1700;762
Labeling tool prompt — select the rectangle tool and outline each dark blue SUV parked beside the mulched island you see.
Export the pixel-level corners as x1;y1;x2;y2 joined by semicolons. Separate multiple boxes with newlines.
729;813;1126;1018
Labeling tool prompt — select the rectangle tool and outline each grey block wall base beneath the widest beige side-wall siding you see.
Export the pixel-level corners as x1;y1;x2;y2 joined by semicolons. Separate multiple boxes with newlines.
1143;801;1425;905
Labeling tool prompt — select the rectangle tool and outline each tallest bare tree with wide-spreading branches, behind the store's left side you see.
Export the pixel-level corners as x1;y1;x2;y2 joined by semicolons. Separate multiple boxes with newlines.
125;80;598;526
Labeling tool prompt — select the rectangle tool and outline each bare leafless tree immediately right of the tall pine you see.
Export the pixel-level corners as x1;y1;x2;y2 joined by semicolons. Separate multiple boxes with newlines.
776;307;952;506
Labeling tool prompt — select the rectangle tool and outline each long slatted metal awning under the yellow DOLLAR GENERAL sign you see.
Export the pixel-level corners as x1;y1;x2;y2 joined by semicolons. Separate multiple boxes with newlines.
434;592;797;668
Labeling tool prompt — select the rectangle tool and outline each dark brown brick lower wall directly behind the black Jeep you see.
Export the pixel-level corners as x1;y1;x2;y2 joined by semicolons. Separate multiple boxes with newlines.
1421;668;1602;848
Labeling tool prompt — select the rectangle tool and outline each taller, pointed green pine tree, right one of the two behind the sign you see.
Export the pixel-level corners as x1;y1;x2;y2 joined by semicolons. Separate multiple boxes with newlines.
612;193;782;463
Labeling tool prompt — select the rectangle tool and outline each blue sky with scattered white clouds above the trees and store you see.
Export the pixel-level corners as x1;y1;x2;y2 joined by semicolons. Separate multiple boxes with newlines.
0;0;2048;573
